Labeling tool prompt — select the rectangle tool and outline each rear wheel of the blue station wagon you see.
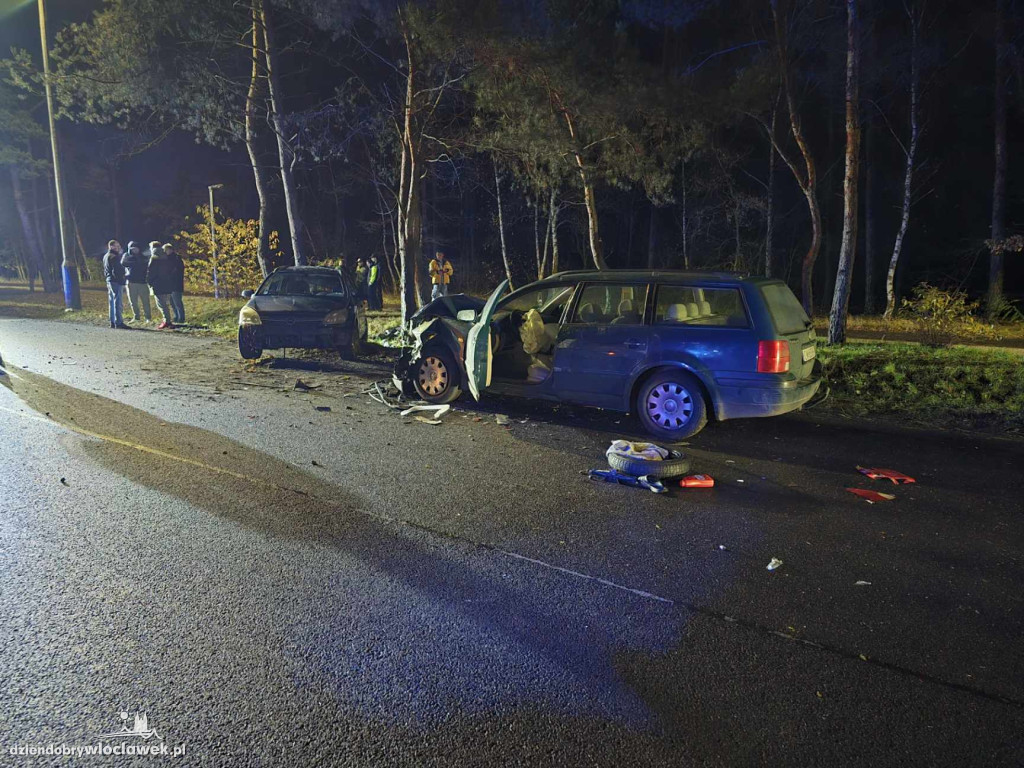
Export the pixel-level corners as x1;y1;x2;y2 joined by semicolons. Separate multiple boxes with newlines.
635;371;708;441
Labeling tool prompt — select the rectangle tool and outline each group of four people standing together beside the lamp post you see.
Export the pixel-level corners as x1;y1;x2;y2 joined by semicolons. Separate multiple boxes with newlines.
103;240;185;329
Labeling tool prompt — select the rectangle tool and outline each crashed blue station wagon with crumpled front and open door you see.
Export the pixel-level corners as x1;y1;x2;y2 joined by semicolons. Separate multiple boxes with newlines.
398;270;820;440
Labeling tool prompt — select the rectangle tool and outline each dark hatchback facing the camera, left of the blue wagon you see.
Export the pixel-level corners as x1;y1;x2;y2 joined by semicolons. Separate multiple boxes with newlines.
239;266;367;359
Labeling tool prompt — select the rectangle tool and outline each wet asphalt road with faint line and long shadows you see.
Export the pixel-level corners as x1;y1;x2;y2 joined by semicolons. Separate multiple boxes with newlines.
0;319;1024;766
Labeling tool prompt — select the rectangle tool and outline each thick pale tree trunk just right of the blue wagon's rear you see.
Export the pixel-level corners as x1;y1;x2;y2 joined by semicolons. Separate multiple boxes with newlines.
828;0;860;344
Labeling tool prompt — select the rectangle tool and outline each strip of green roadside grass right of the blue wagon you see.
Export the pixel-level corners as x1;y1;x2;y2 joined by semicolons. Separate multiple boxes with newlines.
818;342;1024;432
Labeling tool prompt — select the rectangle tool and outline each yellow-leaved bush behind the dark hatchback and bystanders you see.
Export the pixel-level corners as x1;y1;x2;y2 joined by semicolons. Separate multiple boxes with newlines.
174;206;281;298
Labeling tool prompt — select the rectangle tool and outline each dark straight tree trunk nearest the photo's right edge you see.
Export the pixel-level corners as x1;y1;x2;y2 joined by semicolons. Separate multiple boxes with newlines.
986;0;1008;319
